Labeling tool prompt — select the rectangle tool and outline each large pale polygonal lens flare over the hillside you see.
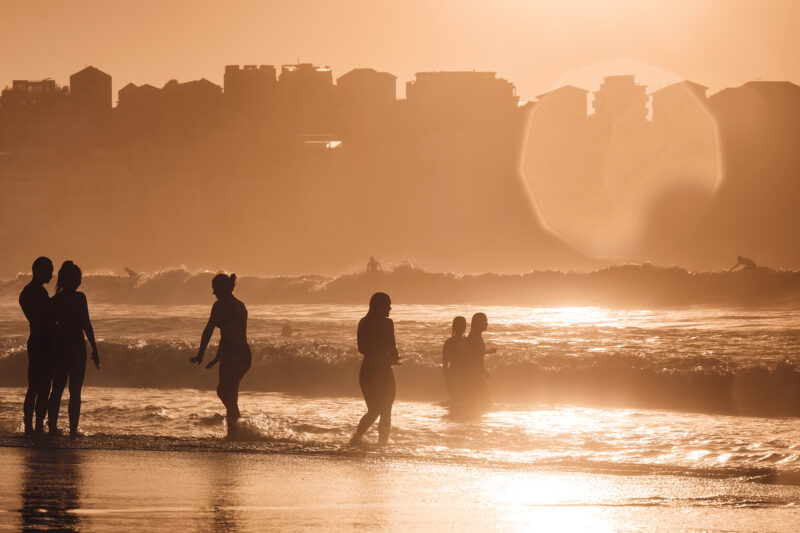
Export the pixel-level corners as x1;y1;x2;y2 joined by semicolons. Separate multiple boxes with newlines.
522;61;721;260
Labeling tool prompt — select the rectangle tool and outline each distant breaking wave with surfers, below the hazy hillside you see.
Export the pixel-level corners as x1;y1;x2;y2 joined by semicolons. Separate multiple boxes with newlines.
0;263;800;306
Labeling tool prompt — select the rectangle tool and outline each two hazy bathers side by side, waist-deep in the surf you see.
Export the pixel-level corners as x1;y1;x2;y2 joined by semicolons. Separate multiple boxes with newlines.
442;313;496;409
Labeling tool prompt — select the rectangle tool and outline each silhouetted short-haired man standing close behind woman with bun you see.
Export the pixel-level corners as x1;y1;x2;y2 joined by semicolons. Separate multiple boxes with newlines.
19;257;55;435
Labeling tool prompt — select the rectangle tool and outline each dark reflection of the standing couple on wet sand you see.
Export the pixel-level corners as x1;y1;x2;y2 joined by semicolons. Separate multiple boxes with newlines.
20;448;83;531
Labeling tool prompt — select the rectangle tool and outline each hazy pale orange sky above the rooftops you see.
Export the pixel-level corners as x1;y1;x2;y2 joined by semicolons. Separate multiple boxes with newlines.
0;0;800;100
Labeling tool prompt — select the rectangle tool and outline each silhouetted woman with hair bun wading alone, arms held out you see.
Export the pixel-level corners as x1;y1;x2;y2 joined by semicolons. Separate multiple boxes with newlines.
189;274;253;439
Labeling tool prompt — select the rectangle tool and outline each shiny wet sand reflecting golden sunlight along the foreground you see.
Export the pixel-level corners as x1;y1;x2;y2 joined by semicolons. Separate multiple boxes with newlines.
0;447;800;531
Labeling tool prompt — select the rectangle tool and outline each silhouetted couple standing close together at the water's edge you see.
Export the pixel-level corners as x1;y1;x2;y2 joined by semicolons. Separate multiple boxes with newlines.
19;257;100;437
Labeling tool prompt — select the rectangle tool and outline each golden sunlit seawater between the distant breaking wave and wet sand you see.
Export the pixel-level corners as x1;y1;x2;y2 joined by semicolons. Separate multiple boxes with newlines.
0;302;800;524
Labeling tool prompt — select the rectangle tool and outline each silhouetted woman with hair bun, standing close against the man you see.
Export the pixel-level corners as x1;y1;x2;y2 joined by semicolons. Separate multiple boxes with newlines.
47;261;100;437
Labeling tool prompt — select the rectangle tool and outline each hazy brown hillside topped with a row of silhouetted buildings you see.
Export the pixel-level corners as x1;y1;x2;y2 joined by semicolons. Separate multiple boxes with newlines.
0;63;800;274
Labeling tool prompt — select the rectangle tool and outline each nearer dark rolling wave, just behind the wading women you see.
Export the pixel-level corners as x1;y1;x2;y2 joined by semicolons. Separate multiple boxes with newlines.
0;339;800;416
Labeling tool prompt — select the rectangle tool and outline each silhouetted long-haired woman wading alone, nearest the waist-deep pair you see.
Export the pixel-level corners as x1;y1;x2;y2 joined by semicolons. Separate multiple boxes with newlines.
350;292;400;445
